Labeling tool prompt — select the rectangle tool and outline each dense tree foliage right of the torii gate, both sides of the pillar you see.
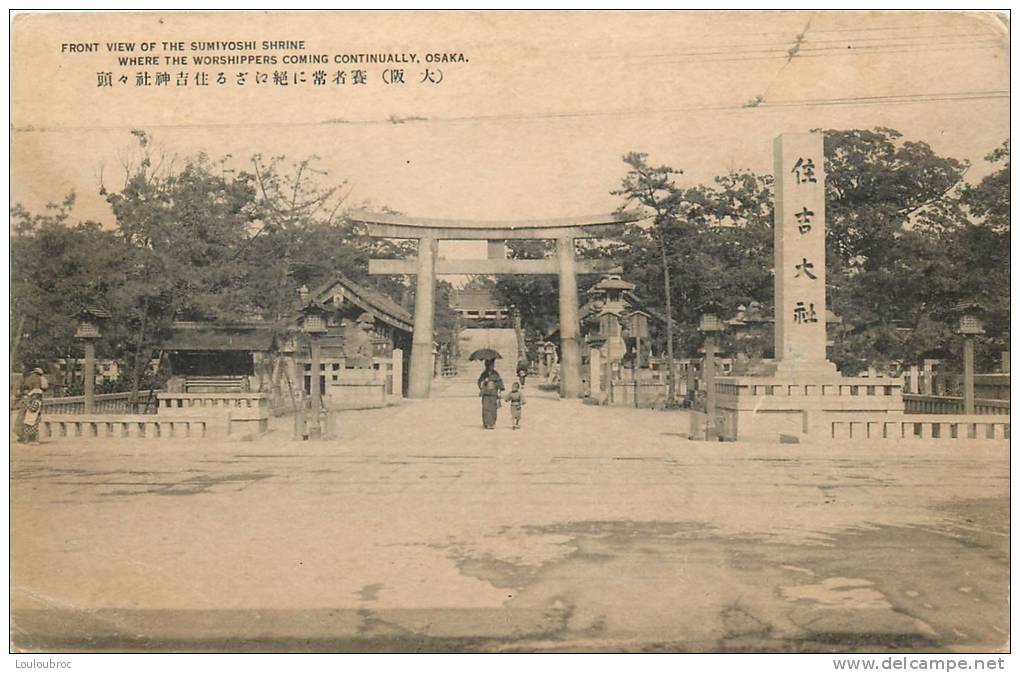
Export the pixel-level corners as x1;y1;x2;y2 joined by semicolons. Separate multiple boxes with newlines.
498;128;1010;374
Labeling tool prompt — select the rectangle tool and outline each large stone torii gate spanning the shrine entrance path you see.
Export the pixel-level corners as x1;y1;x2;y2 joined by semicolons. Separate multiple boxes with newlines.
350;211;642;398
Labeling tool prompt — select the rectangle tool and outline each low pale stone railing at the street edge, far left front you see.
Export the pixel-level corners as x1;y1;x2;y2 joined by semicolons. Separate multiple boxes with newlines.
39;414;212;439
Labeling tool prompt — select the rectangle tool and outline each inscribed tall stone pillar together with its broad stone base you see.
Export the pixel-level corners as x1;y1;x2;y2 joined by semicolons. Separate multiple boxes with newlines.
705;134;904;441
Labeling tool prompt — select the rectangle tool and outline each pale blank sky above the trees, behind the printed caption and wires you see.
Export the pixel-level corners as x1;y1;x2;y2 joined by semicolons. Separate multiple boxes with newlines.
11;11;1009;263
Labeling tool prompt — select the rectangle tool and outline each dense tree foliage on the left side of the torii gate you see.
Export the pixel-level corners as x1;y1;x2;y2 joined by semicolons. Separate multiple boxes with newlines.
10;132;442;389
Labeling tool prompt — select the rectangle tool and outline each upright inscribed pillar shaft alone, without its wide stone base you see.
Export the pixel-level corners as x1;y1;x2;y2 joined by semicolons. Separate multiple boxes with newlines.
773;134;835;375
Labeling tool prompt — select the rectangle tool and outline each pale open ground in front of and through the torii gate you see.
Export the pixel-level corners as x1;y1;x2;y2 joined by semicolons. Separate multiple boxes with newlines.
11;381;1009;652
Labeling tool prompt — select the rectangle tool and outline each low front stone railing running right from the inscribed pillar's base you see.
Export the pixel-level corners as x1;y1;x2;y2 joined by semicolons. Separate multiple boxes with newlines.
826;414;1010;442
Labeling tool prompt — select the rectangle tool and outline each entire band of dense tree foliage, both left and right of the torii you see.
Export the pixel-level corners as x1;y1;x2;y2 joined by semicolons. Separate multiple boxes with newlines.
10;128;1010;385
